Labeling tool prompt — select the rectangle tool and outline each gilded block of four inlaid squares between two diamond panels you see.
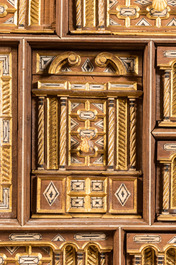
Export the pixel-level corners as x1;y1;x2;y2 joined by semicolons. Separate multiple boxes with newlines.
67;178;107;213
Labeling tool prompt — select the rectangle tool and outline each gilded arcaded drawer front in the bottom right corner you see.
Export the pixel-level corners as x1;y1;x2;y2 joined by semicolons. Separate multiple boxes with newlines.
127;232;176;265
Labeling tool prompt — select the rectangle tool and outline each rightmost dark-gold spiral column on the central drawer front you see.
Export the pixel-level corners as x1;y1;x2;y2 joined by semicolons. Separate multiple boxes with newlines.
129;99;136;170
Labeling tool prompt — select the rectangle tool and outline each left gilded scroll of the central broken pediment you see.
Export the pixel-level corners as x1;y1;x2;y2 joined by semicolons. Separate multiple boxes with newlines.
48;52;81;74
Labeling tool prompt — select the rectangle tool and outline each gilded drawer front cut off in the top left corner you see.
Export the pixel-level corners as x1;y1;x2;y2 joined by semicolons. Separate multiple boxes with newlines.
0;0;56;33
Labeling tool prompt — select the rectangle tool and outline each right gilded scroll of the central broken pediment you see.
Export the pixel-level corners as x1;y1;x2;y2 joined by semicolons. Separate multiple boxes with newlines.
95;52;127;75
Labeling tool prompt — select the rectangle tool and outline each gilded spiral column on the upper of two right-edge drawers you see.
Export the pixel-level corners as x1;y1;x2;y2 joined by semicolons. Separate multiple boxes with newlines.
163;70;171;119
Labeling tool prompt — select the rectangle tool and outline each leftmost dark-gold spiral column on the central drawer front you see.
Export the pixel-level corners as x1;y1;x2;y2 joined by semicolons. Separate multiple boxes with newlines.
38;97;44;169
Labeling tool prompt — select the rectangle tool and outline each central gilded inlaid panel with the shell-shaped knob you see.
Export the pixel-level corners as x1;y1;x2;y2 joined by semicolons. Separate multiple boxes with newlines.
69;99;106;168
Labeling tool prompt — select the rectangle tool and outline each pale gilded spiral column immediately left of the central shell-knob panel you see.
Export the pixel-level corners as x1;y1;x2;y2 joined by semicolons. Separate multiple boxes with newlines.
60;97;67;170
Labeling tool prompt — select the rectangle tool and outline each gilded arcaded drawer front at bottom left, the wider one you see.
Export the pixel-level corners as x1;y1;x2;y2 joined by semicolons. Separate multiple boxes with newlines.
0;231;113;265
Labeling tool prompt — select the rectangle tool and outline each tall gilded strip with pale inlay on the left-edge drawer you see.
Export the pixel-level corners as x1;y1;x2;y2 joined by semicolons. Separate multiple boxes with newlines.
0;54;12;212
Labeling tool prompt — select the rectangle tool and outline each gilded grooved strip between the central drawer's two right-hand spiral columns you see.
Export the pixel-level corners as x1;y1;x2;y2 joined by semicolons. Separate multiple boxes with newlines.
117;98;127;170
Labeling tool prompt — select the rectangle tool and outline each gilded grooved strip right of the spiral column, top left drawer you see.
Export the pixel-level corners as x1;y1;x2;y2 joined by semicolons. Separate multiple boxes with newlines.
30;0;40;25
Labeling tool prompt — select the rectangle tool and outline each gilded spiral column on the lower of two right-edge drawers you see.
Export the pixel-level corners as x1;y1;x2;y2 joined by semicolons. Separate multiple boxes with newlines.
163;164;170;211
